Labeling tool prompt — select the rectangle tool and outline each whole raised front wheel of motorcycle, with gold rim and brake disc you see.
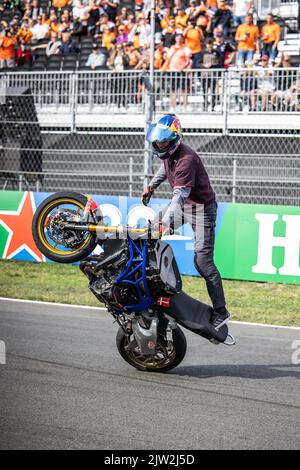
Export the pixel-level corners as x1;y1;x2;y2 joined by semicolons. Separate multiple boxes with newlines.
32;192;96;263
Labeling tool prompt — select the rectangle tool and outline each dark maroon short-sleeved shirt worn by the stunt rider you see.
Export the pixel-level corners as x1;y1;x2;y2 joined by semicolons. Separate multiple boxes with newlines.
164;144;216;204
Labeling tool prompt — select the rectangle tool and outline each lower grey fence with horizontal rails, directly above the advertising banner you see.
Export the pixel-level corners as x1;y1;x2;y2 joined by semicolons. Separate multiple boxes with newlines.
0;132;300;205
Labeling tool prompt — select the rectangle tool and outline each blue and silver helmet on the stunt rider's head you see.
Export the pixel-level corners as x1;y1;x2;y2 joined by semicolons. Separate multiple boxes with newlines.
146;114;182;160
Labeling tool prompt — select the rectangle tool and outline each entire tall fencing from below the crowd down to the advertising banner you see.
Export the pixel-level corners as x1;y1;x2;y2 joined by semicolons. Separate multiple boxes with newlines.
0;69;300;205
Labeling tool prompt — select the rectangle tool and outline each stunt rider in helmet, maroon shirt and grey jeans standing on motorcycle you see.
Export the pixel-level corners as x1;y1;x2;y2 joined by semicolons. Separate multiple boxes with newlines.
142;114;230;330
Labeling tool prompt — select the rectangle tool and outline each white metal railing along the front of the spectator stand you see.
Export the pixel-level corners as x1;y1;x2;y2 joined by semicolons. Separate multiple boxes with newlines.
0;65;300;122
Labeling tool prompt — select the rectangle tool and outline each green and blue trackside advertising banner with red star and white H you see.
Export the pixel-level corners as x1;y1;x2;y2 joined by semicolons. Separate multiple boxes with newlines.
0;191;300;284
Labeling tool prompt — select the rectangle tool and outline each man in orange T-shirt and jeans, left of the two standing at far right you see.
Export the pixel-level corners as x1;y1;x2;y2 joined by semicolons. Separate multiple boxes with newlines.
235;14;259;65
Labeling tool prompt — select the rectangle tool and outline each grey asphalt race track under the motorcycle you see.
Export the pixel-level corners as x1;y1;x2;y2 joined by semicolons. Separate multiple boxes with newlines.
0;300;300;450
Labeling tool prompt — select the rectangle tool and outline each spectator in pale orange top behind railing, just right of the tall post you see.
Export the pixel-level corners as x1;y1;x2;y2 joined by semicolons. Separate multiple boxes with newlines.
162;34;192;111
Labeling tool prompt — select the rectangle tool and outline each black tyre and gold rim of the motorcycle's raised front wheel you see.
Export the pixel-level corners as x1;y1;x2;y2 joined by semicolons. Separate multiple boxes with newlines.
32;191;96;263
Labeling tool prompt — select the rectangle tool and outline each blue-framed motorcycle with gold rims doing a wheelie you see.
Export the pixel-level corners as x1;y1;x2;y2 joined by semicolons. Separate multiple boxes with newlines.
32;192;235;372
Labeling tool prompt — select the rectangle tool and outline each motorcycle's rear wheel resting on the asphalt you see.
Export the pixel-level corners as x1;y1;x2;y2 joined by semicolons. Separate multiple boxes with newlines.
117;327;187;372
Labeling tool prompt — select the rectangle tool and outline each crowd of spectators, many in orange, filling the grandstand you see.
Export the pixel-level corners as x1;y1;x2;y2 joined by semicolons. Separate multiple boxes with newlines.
0;0;292;71
